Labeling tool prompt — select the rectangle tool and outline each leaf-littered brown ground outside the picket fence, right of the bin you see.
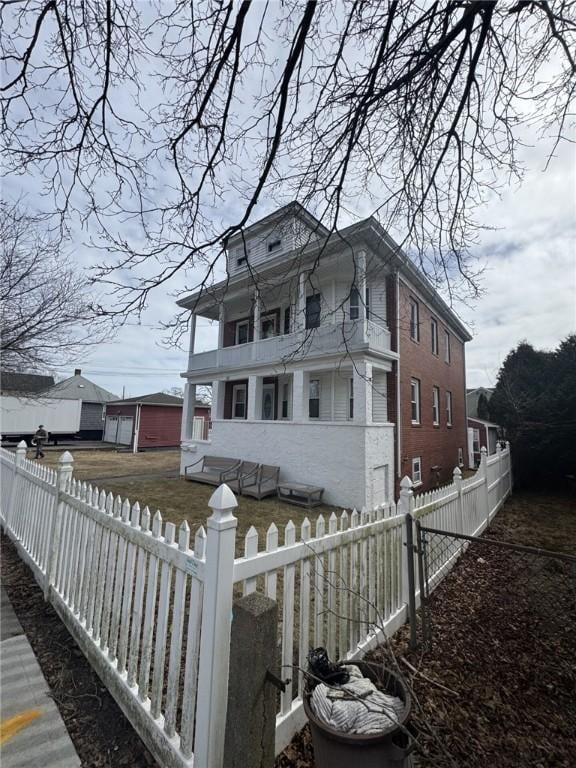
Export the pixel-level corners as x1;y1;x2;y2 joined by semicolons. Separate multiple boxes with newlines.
276;494;576;768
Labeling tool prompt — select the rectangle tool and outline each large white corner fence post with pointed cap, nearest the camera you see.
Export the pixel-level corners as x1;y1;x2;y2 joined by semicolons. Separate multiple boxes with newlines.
194;485;238;768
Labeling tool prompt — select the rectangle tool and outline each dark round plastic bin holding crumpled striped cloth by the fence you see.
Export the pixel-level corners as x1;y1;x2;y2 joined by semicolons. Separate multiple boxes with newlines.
304;661;416;768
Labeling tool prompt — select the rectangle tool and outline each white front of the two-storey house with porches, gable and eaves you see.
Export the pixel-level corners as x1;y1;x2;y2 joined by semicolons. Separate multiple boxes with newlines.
179;204;469;506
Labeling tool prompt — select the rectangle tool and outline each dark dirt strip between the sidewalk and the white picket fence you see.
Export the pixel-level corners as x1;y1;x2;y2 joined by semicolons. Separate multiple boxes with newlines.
1;536;156;768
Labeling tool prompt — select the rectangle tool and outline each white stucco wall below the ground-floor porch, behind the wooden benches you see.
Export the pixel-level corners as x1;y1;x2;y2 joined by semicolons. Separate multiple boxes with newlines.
181;420;394;508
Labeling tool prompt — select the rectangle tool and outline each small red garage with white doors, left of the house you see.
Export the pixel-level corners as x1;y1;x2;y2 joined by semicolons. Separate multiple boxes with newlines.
104;392;184;452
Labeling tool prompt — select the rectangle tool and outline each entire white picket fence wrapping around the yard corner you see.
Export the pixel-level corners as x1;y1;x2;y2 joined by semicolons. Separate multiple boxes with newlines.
0;440;512;768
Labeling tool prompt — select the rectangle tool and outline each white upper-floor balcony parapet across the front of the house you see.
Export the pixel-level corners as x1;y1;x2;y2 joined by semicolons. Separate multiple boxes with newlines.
188;320;395;374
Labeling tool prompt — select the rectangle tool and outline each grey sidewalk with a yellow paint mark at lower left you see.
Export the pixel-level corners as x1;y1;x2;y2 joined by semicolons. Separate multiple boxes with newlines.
0;586;81;768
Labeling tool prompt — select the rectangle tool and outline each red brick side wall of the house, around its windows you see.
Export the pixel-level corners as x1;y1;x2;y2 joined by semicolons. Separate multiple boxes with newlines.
399;280;468;491
